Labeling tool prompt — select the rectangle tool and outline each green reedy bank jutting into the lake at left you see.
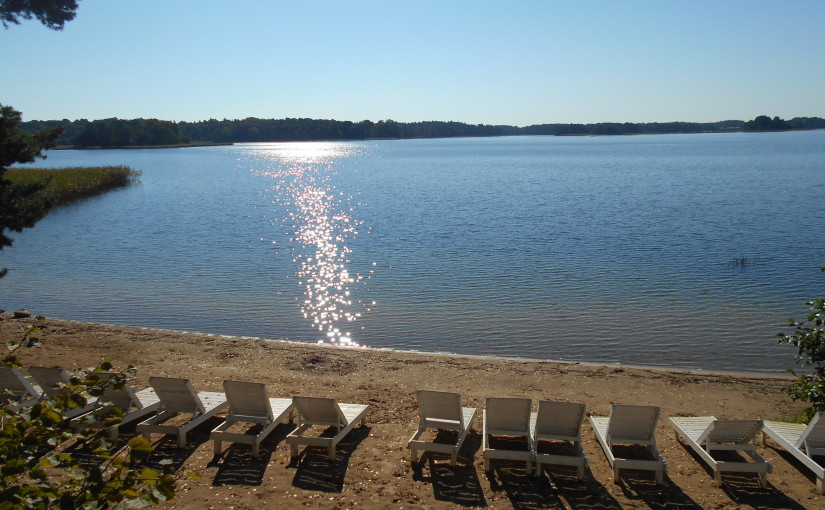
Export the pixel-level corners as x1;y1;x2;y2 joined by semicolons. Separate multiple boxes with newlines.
4;166;140;206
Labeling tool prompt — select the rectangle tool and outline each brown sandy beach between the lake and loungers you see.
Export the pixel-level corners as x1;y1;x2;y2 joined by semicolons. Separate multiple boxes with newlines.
0;314;825;509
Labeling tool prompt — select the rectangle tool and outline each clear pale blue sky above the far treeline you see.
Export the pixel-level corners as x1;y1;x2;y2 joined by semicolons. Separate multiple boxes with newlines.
0;0;825;126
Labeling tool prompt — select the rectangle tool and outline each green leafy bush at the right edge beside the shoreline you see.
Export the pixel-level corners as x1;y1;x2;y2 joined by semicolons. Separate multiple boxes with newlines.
779;267;825;419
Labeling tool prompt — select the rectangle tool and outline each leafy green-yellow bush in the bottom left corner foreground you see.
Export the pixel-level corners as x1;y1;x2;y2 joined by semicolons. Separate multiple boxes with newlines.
0;320;175;510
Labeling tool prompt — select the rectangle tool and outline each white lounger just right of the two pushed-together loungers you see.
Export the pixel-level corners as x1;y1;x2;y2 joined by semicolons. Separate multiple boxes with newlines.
590;404;667;483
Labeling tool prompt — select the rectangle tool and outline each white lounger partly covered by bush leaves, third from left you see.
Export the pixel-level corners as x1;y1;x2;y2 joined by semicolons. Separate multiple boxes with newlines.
69;372;160;439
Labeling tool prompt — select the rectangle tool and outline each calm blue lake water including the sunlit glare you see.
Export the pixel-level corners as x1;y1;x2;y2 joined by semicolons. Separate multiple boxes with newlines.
0;131;825;372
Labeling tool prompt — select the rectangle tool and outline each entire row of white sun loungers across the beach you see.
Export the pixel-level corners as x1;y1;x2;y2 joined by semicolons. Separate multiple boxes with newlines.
0;365;825;493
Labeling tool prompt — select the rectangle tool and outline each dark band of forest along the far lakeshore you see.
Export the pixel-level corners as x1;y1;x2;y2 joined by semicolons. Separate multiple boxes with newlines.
20;115;825;148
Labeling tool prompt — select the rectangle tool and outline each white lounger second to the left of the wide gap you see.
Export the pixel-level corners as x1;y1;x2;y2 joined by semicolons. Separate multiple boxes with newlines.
210;381;294;457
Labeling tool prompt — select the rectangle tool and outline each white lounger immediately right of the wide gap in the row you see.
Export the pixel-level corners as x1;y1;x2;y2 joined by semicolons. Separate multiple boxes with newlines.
407;390;476;466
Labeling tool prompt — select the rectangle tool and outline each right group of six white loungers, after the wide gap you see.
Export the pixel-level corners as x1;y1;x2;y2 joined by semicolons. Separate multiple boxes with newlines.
408;390;825;493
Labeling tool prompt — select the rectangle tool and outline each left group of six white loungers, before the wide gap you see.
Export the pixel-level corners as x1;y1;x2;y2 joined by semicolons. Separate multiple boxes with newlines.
0;365;369;460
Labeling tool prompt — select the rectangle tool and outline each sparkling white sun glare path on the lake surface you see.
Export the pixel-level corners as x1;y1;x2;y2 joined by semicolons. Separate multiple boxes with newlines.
256;143;366;346
